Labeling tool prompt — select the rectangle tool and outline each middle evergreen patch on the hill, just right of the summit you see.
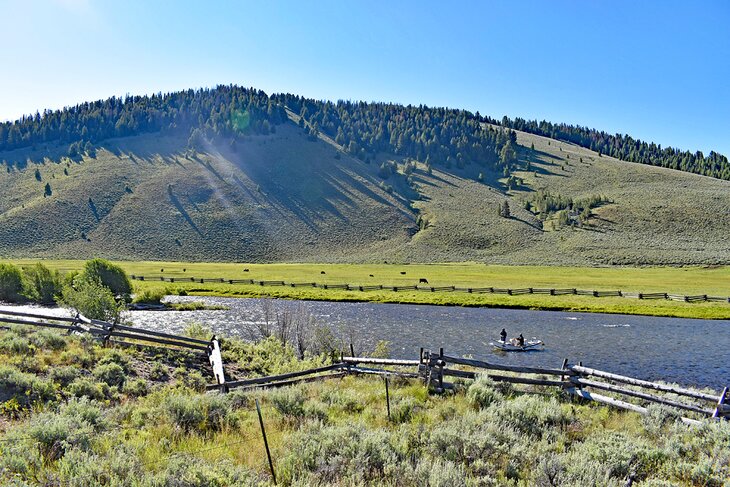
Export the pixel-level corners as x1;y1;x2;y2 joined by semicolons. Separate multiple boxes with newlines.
272;94;517;171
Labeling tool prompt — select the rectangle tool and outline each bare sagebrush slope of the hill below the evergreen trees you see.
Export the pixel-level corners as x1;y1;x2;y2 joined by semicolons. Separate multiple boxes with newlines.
0;100;730;265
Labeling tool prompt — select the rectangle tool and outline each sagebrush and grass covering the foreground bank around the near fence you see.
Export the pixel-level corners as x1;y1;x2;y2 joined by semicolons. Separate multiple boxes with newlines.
0;327;730;487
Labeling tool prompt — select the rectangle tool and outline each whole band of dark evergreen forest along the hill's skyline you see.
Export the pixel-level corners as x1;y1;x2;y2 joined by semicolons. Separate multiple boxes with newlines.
0;85;730;180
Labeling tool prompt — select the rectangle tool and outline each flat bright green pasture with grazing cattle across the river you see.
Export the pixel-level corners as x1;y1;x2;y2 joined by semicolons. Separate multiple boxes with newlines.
12;259;730;319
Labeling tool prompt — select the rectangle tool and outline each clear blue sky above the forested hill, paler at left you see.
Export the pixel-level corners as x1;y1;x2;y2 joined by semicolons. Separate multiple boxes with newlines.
0;0;730;155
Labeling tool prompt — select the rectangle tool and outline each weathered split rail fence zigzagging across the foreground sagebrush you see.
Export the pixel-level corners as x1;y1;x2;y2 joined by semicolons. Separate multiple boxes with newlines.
0;309;730;424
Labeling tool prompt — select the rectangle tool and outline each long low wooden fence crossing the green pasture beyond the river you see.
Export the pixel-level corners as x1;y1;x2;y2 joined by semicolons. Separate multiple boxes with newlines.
130;274;730;303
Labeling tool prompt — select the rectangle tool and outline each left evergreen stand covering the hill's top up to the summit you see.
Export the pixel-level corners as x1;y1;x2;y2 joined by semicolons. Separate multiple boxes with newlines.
0;85;286;152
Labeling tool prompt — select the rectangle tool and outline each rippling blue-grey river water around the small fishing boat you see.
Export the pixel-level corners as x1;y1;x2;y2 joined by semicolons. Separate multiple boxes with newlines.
2;296;730;390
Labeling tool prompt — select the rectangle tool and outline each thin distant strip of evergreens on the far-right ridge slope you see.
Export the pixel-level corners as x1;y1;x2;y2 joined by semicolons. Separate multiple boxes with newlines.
502;117;730;180
